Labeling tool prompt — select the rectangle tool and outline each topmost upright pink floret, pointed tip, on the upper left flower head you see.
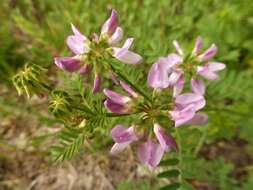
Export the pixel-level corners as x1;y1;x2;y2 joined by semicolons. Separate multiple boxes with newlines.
101;9;118;36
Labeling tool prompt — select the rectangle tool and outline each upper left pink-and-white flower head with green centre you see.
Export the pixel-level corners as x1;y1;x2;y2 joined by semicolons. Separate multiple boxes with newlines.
54;10;142;93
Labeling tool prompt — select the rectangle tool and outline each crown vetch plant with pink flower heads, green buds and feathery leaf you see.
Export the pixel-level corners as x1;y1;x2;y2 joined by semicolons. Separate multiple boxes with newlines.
13;7;225;189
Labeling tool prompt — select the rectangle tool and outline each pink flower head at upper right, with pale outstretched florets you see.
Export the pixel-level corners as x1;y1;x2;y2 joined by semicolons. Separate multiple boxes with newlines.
148;37;225;97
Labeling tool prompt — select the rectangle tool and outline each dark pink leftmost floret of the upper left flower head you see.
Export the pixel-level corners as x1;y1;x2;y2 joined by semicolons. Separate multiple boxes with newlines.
54;57;81;72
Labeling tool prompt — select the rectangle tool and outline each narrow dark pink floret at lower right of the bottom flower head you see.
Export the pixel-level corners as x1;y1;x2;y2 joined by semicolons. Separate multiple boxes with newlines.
154;123;178;151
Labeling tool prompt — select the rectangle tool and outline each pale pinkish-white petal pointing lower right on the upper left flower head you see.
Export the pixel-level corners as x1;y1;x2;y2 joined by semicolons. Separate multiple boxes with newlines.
113;48;142;64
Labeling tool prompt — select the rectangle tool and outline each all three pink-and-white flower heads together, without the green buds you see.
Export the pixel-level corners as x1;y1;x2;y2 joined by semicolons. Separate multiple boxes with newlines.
52;10;225;169
